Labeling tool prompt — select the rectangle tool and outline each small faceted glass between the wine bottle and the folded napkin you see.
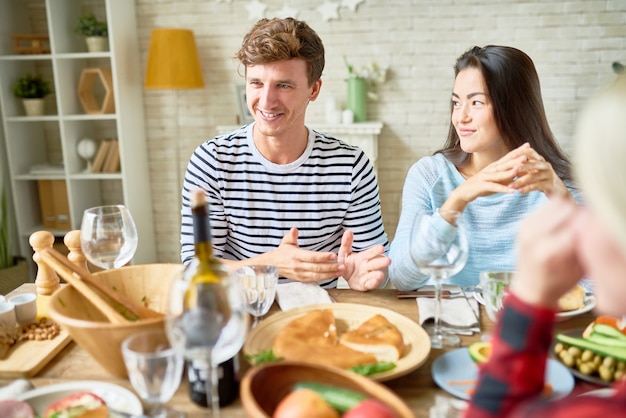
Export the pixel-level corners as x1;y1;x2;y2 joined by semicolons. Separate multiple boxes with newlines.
233;265;278;328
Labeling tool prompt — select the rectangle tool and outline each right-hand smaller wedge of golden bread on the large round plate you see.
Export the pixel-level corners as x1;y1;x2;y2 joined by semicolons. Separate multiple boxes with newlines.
339;314;404;363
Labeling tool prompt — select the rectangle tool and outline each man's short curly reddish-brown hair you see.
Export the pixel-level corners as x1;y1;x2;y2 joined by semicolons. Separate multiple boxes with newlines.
236;17;325;87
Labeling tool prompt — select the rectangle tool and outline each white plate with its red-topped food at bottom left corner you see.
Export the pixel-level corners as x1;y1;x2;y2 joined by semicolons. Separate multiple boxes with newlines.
16;380;143;416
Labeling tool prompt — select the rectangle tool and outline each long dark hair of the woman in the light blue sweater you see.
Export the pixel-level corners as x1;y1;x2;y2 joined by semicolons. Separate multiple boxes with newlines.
437;45;572;181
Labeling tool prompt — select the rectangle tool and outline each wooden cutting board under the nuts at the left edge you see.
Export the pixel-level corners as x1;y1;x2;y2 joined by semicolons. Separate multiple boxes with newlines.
0;329;72;378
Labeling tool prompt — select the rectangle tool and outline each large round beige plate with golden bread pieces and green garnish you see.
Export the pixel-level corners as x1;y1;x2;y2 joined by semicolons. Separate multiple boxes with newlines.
243;303;430;381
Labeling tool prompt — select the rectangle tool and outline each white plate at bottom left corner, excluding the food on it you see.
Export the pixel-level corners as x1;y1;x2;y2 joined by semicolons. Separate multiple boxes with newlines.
17;380;143;415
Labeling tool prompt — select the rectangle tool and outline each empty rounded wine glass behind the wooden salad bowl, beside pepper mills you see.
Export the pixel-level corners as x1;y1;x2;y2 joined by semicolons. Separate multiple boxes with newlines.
80;205;138;269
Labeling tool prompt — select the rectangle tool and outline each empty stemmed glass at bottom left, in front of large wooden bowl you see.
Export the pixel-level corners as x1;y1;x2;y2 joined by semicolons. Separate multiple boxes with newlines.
122;330;185;418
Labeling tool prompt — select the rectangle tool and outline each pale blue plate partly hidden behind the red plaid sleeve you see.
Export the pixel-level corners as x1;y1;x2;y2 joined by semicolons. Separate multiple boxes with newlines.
432;347;574;400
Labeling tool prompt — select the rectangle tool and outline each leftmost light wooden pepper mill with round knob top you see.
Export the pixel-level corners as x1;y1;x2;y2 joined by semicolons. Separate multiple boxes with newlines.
28;231;60;319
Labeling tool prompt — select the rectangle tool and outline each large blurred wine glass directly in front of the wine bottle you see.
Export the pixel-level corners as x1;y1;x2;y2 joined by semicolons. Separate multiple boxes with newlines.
166;259;249;417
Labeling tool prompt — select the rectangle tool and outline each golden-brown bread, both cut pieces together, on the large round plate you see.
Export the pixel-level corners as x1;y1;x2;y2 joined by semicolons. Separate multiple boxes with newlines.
272;309;404;369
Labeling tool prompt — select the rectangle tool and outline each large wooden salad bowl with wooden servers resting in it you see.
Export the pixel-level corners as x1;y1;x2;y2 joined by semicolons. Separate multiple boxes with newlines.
48;264;183;377
